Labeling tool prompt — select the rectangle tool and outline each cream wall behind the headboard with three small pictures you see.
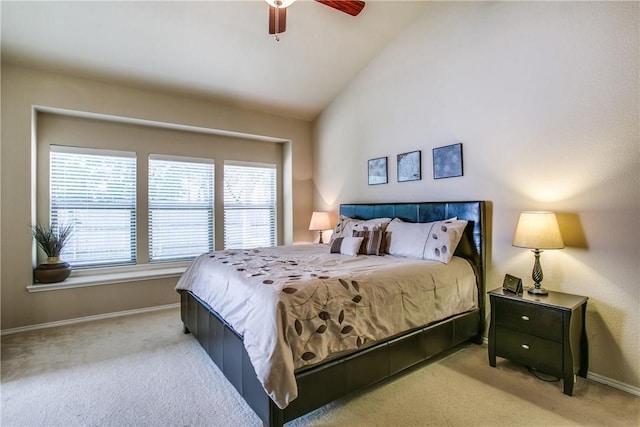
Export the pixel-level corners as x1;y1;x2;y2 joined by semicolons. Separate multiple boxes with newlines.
314;2;640;391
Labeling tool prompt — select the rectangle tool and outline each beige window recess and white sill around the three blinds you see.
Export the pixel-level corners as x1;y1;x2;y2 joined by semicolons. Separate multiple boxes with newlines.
33;110;284;292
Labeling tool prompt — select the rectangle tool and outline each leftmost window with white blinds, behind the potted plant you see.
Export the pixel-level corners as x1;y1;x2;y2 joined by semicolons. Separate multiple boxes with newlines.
49;146;136;267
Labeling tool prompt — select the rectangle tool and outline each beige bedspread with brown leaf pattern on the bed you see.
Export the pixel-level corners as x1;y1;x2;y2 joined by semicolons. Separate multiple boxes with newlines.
176;245;477;408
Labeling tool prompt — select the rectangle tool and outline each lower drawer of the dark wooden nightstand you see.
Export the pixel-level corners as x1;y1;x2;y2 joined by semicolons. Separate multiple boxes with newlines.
496;329;562;375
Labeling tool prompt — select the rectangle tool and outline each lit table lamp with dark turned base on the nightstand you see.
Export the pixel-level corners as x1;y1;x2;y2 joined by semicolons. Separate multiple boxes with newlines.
512;211;564;295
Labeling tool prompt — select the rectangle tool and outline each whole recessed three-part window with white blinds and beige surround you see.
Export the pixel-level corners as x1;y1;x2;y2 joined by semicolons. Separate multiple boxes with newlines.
38;111;285;278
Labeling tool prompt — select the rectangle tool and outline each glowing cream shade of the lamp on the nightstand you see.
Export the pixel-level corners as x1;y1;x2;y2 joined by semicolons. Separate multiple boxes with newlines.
513;211;564;249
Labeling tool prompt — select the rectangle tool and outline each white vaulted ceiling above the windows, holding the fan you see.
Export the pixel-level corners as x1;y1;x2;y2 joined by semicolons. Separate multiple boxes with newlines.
0;0;428;120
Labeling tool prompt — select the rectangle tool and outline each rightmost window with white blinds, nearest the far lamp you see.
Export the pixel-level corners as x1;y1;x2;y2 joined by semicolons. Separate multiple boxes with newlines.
224;164;277;249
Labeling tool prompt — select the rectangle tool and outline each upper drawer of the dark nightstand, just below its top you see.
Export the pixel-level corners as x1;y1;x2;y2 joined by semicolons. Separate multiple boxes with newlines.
492;299;562;342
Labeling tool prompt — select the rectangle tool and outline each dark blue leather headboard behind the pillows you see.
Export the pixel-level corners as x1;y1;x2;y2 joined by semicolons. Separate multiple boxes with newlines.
340;201;486;318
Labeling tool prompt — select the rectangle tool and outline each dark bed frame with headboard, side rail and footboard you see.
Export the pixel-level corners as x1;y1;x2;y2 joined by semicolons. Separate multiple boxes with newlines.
180;201;486;426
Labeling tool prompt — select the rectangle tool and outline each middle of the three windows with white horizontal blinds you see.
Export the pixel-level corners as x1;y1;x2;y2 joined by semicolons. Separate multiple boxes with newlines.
149;155;214;262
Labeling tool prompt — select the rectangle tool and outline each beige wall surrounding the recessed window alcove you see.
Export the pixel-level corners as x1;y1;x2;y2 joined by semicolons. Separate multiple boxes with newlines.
0;63;314;330
